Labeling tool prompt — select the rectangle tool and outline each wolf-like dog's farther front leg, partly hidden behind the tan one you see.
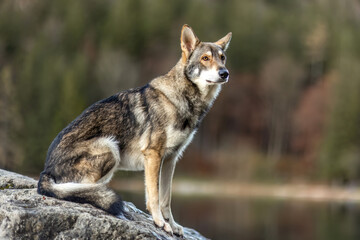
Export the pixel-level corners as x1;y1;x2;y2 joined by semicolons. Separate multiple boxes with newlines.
160;158;184;236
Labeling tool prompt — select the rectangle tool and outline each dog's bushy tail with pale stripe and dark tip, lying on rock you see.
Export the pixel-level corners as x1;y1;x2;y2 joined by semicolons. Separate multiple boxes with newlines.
38;173;124;216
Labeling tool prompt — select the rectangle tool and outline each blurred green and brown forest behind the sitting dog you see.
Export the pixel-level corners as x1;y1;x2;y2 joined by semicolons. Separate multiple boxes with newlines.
0;0;360;184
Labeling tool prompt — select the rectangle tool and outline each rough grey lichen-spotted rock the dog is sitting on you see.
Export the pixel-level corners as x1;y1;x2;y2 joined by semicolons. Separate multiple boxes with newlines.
0;169;206;240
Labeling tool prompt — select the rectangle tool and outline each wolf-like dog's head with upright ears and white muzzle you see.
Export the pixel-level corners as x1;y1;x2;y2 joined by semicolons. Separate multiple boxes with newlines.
180;25;232;86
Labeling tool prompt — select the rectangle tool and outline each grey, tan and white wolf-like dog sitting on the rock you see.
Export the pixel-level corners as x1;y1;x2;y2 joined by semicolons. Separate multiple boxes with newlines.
38;25;231;235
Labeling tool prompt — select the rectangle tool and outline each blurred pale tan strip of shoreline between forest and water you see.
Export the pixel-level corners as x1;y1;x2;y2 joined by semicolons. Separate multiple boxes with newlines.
110;179;360;203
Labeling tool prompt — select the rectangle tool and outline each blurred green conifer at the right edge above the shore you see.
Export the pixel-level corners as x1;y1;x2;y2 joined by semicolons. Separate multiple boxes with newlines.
320;58;360;182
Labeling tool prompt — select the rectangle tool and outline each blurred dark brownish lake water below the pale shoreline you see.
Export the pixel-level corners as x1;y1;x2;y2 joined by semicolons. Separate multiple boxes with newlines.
121;192;360;240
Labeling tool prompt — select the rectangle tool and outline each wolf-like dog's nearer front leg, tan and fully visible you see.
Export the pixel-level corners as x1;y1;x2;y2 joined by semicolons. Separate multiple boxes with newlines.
143;149;173;234
